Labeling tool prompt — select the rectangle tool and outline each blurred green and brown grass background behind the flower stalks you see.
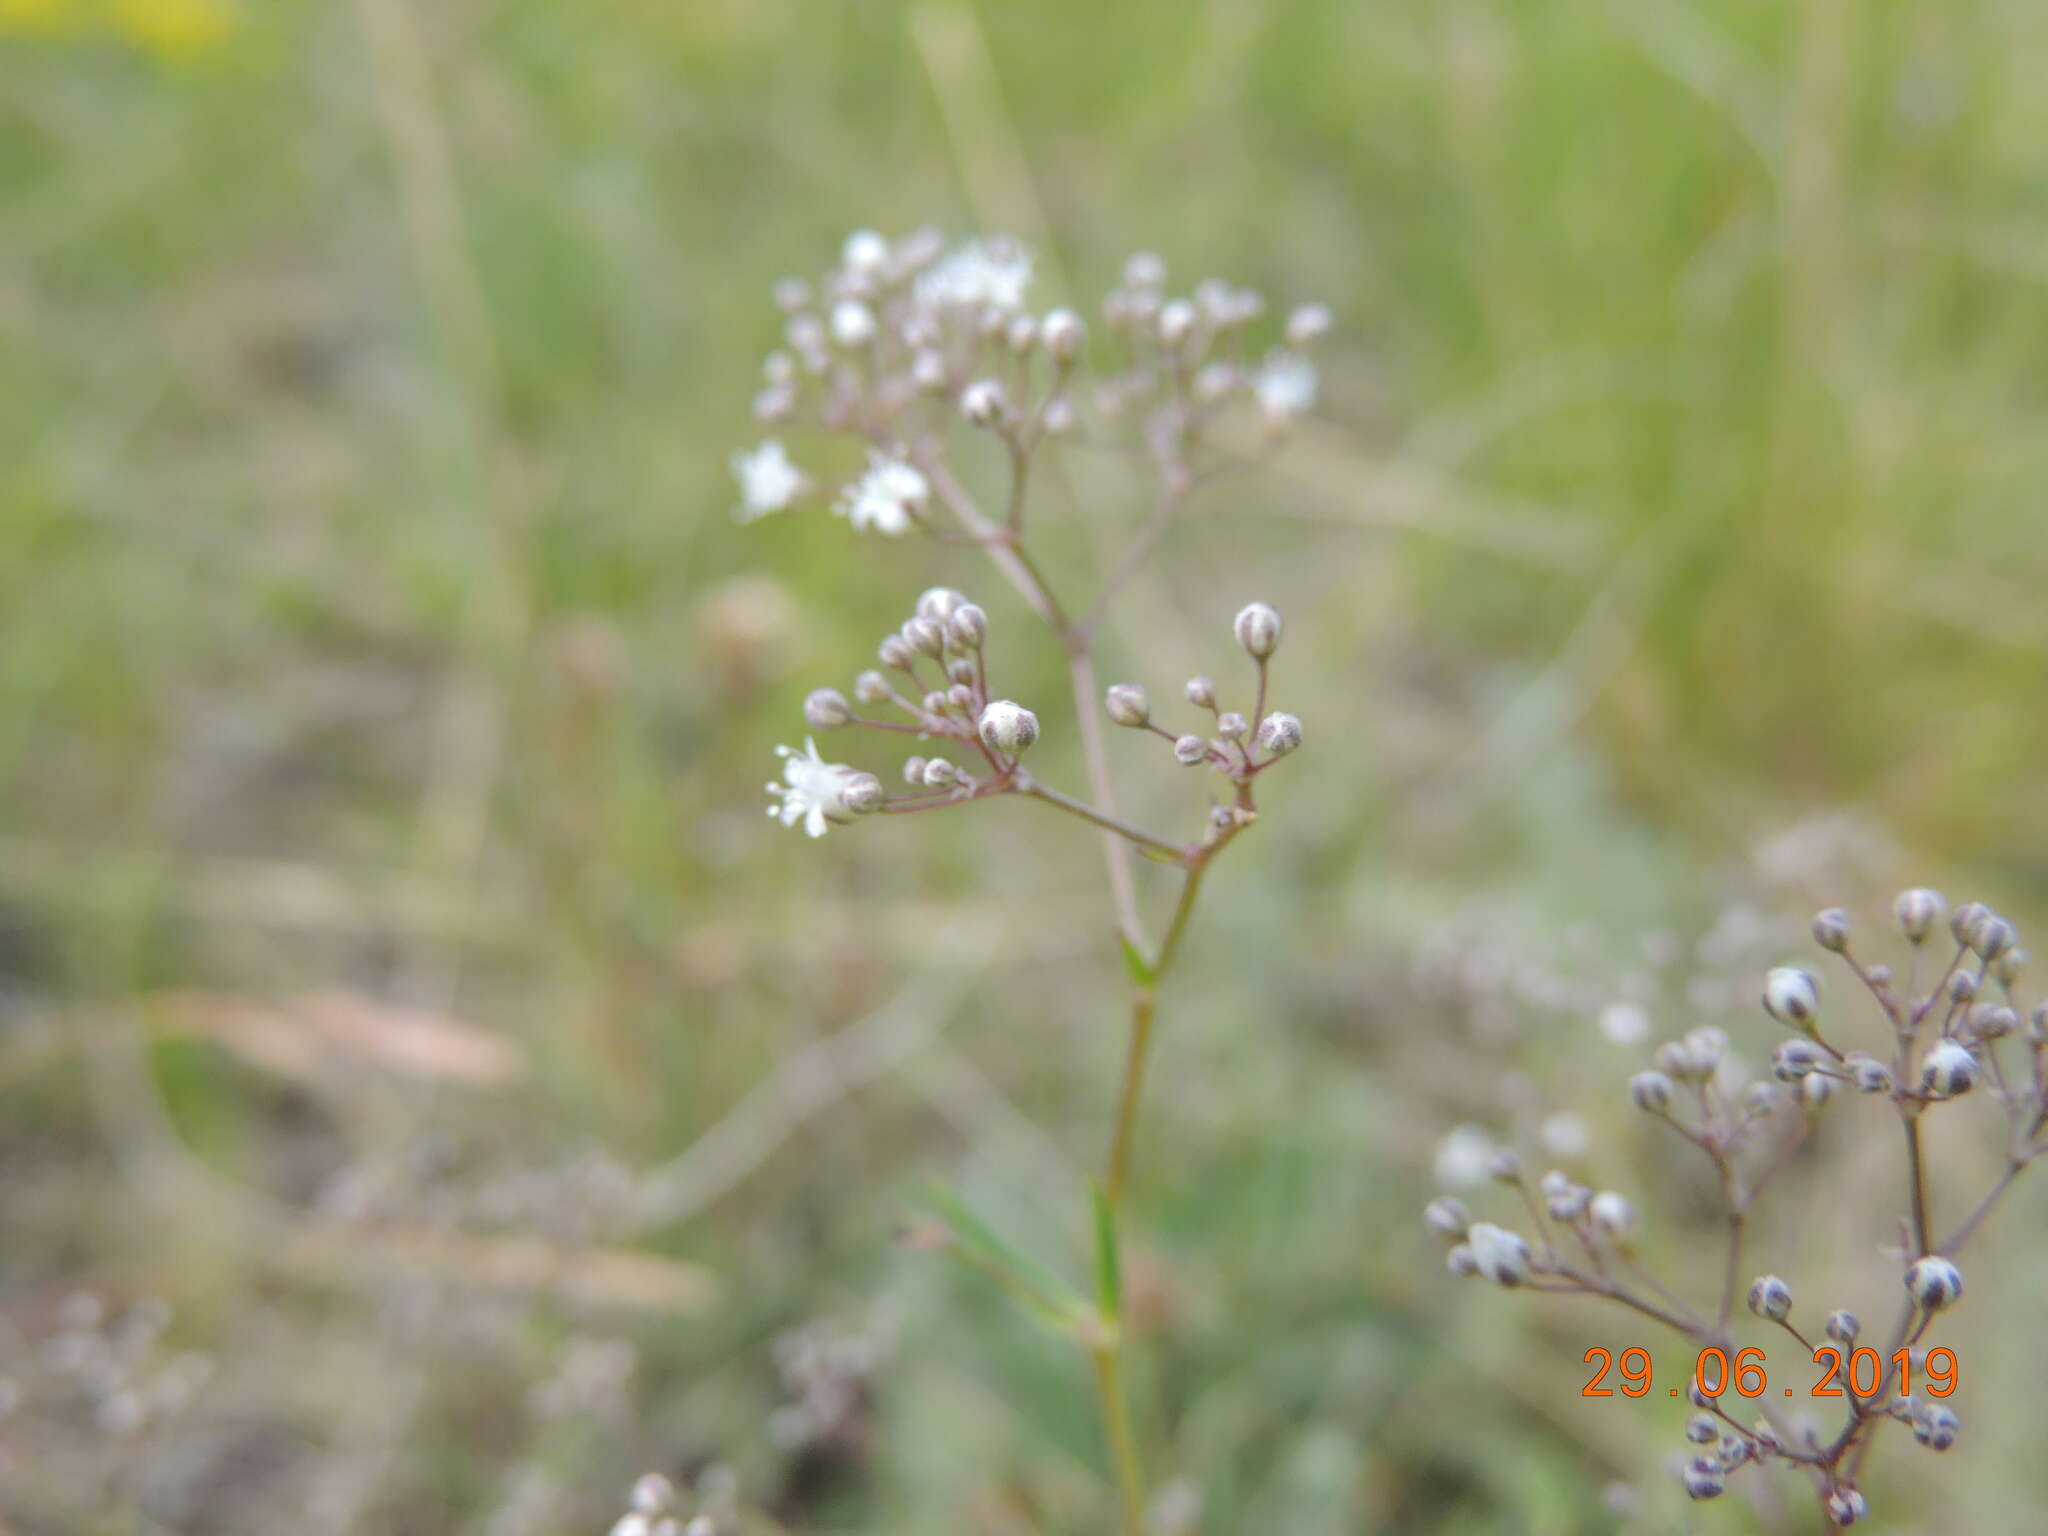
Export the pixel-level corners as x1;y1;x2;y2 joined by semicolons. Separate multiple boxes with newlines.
0;0;2048;1534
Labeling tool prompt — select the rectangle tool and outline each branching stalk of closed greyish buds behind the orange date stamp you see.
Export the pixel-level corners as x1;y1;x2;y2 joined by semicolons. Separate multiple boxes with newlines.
1425;889;2048;1528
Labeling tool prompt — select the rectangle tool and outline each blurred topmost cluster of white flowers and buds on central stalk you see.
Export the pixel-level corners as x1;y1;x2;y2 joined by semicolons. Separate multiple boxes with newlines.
733;229;1331;537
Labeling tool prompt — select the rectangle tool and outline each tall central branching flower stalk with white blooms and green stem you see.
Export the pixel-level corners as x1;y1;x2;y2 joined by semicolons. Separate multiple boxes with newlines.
733;231;1329;1536
